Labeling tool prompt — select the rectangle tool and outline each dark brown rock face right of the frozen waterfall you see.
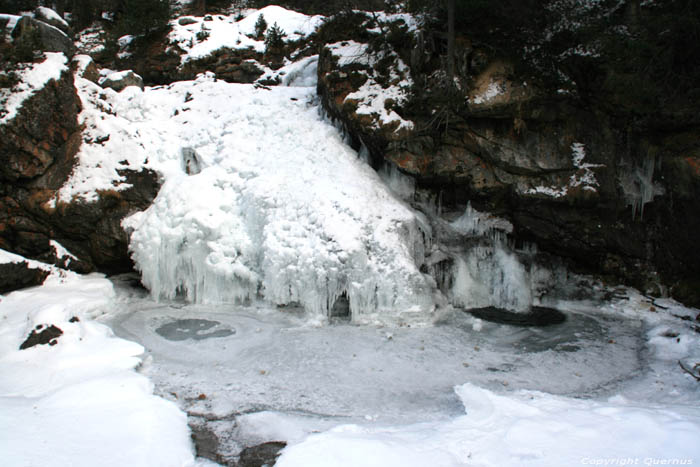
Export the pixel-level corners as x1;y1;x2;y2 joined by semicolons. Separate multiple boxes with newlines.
318;14;700;305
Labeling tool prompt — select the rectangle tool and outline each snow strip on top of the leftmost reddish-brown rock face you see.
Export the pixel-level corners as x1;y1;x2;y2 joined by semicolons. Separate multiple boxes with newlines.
0;52;68;125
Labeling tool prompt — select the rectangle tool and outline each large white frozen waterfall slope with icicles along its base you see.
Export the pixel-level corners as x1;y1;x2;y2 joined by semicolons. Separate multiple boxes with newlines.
61;71;434;323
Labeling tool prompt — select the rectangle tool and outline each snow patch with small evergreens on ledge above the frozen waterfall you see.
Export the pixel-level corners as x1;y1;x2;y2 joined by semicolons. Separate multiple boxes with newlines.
168;5;324;64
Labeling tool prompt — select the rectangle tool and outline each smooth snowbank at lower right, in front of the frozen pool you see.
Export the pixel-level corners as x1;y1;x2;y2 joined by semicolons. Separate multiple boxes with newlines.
275;384;700;467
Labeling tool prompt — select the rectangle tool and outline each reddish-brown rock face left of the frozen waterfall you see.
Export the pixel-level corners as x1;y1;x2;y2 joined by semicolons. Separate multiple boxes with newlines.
0;49;159;282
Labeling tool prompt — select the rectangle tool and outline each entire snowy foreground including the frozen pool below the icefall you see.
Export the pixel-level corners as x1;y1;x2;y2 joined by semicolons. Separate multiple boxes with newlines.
0;266;700;467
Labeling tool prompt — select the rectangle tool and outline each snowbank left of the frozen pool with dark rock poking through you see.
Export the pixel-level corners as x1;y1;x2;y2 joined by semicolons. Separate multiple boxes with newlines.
0;268;194;467
